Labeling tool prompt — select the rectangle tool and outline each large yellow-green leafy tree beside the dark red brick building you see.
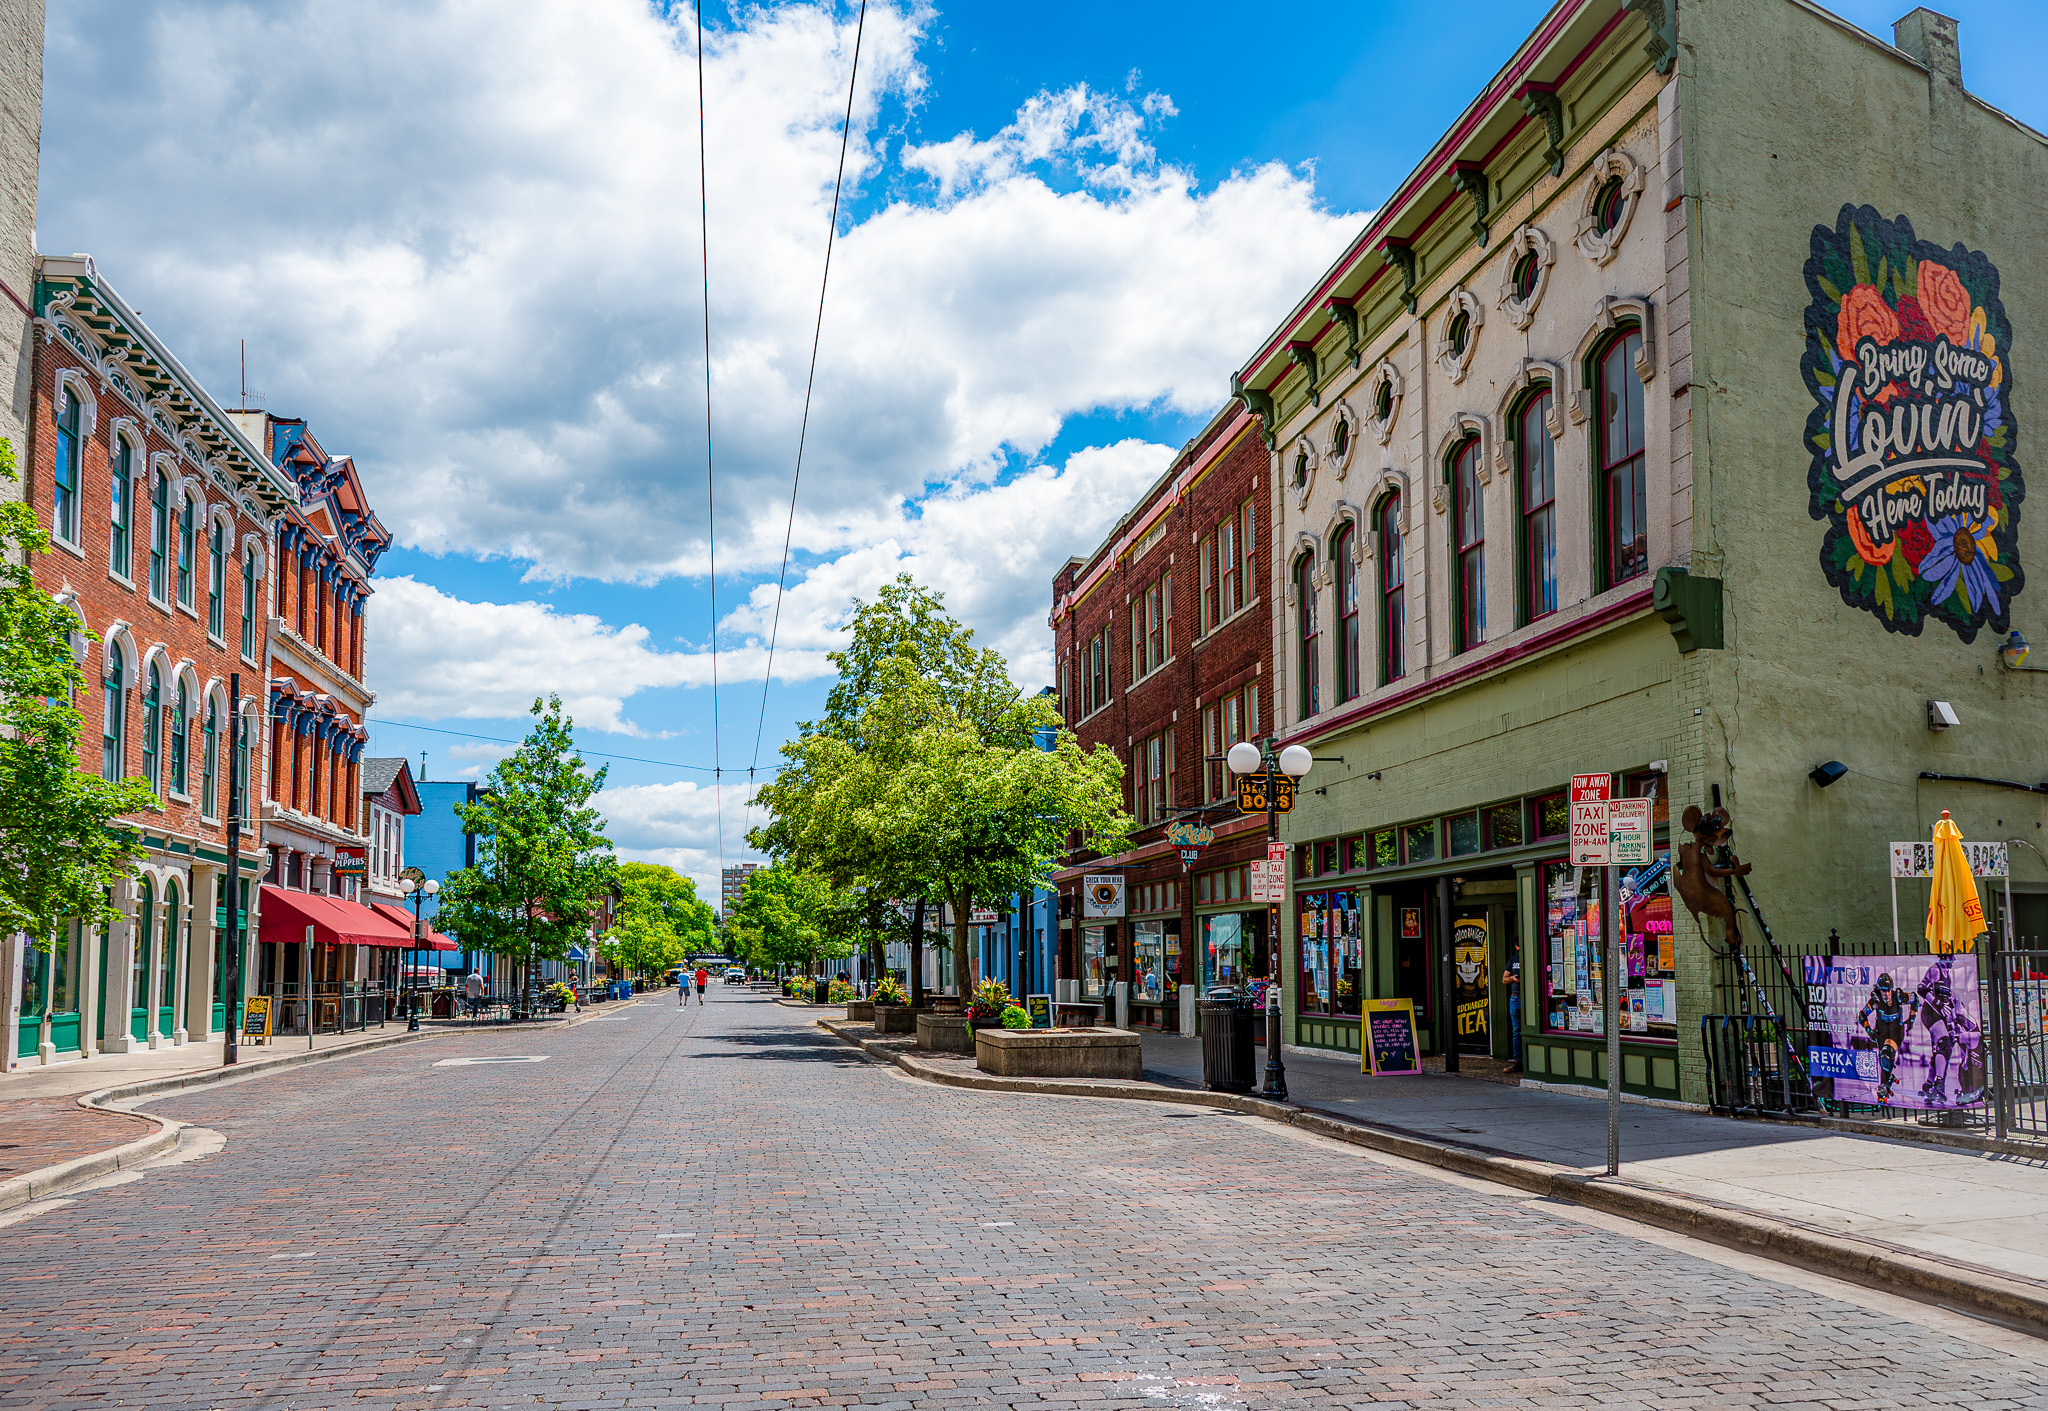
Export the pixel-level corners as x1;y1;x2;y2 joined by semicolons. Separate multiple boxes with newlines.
748;578;1133;985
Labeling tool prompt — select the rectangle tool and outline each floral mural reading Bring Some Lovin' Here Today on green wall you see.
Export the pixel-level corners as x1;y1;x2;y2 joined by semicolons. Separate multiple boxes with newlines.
1800;205;2025;641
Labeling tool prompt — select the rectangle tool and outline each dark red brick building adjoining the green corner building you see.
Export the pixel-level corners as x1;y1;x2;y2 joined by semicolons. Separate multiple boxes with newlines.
1051;403;1272;1028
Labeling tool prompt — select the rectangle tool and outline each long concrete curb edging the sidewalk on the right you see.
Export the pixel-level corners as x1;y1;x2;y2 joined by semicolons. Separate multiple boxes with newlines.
817;1020;2048;1337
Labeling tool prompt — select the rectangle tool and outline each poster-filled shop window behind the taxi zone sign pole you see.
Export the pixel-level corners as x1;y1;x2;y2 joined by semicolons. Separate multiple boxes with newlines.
1542;852;1677;1038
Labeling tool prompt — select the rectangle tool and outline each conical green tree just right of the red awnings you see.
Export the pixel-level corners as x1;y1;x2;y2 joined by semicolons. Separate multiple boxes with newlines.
436;696;618;1003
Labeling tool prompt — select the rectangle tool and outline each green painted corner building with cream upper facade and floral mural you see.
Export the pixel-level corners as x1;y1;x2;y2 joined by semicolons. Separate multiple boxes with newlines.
1235;0;2048;1102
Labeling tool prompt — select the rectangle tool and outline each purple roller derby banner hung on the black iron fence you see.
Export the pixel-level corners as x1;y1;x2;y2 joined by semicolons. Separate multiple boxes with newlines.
1804;954;1985;1110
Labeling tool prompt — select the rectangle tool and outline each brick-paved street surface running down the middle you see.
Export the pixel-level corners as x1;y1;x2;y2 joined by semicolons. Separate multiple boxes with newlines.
0;991;2048;1411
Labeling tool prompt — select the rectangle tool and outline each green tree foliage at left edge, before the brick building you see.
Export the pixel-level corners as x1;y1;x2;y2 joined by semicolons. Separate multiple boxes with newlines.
0;440;160;950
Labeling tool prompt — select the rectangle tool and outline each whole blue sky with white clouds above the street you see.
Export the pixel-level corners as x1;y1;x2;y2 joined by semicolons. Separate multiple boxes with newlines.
39;0;2048;881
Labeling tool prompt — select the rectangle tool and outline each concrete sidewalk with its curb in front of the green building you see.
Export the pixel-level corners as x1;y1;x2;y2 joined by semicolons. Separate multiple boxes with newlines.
817;1018;2048;1335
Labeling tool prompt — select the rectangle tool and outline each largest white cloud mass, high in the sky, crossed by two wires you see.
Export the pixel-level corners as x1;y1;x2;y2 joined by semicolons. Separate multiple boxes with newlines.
41;0;1358;582
